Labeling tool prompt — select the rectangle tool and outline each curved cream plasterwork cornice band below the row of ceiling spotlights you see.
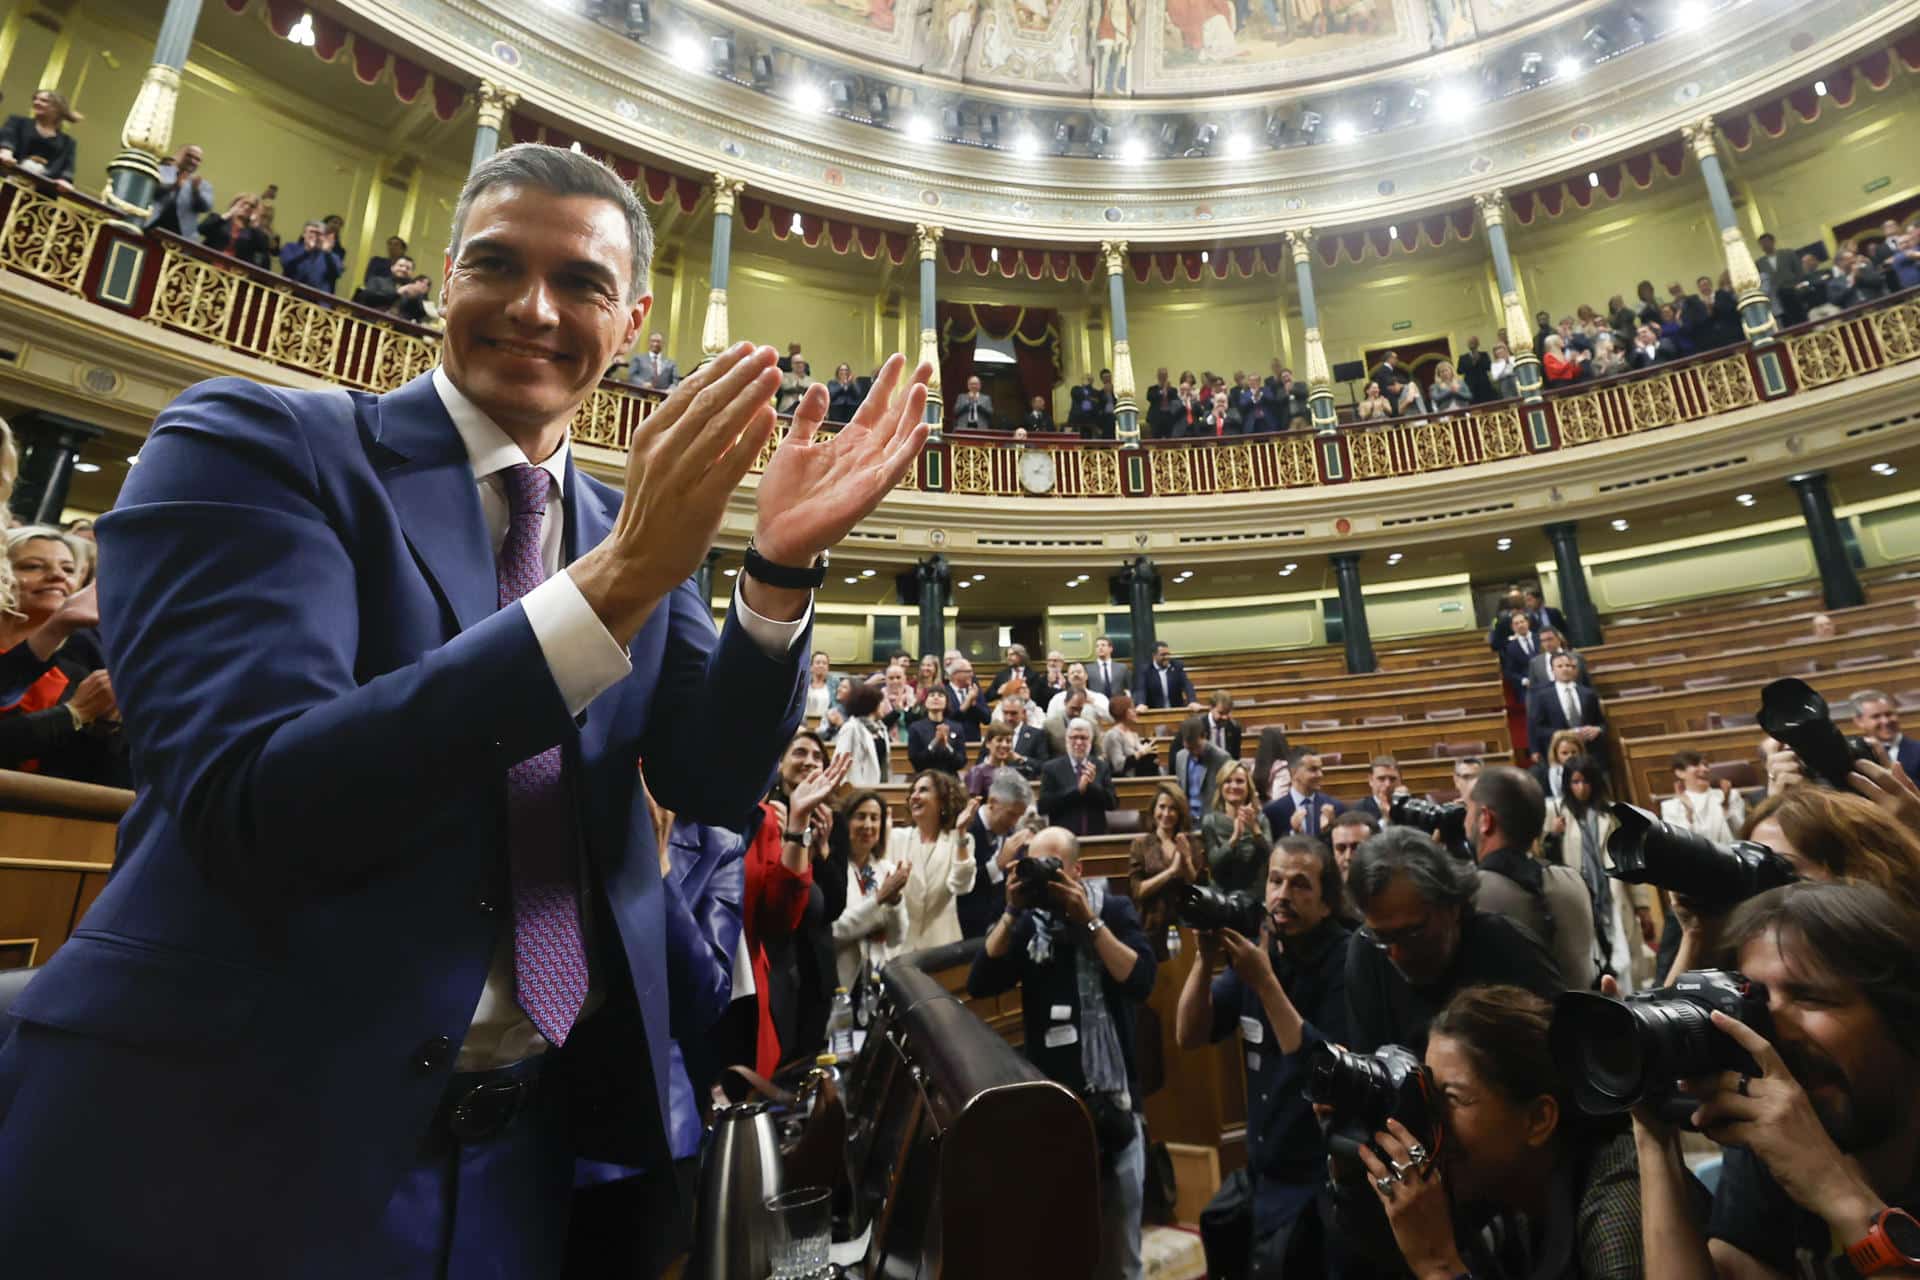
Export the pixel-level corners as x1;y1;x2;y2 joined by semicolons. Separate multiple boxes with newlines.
342;0;1920;248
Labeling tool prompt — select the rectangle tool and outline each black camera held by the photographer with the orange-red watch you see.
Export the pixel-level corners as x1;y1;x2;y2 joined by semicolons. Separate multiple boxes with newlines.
1548;969;1772;1125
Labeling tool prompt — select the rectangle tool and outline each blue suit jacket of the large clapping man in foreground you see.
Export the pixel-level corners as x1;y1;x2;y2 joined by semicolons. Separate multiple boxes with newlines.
0;376;806;1276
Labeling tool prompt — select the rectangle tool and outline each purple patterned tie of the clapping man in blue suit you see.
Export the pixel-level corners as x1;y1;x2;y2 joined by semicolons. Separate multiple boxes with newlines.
495;462;588;1046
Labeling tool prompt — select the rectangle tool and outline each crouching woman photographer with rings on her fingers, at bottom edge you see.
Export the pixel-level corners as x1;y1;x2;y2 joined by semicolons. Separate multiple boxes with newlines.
1359;986;1651;1280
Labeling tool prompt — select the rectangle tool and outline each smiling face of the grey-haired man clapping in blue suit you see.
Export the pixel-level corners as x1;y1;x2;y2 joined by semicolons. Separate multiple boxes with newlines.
442;186;653;445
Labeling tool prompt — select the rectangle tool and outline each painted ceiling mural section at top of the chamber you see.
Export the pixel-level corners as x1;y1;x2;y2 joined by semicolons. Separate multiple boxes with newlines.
698;0;1566;98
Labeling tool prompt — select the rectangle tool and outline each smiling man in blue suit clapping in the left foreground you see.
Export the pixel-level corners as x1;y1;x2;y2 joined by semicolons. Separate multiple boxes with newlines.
0;146;927;1278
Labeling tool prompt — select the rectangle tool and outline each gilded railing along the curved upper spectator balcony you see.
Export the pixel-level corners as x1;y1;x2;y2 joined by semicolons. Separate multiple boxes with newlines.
0;171;1920;499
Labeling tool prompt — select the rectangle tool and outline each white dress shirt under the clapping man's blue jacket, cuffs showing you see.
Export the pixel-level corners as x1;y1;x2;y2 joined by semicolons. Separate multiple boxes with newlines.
434;368;812;1071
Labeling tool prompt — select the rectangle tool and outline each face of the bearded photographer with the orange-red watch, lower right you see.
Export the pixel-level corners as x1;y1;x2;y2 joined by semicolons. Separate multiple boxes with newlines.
1740;931;1916;1151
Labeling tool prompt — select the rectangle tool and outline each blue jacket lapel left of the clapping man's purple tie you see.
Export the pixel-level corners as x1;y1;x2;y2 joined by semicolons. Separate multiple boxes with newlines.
372;374;499;631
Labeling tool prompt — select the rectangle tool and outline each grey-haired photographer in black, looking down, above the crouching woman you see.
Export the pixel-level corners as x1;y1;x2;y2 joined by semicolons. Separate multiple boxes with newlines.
1346;827;1567;1054
